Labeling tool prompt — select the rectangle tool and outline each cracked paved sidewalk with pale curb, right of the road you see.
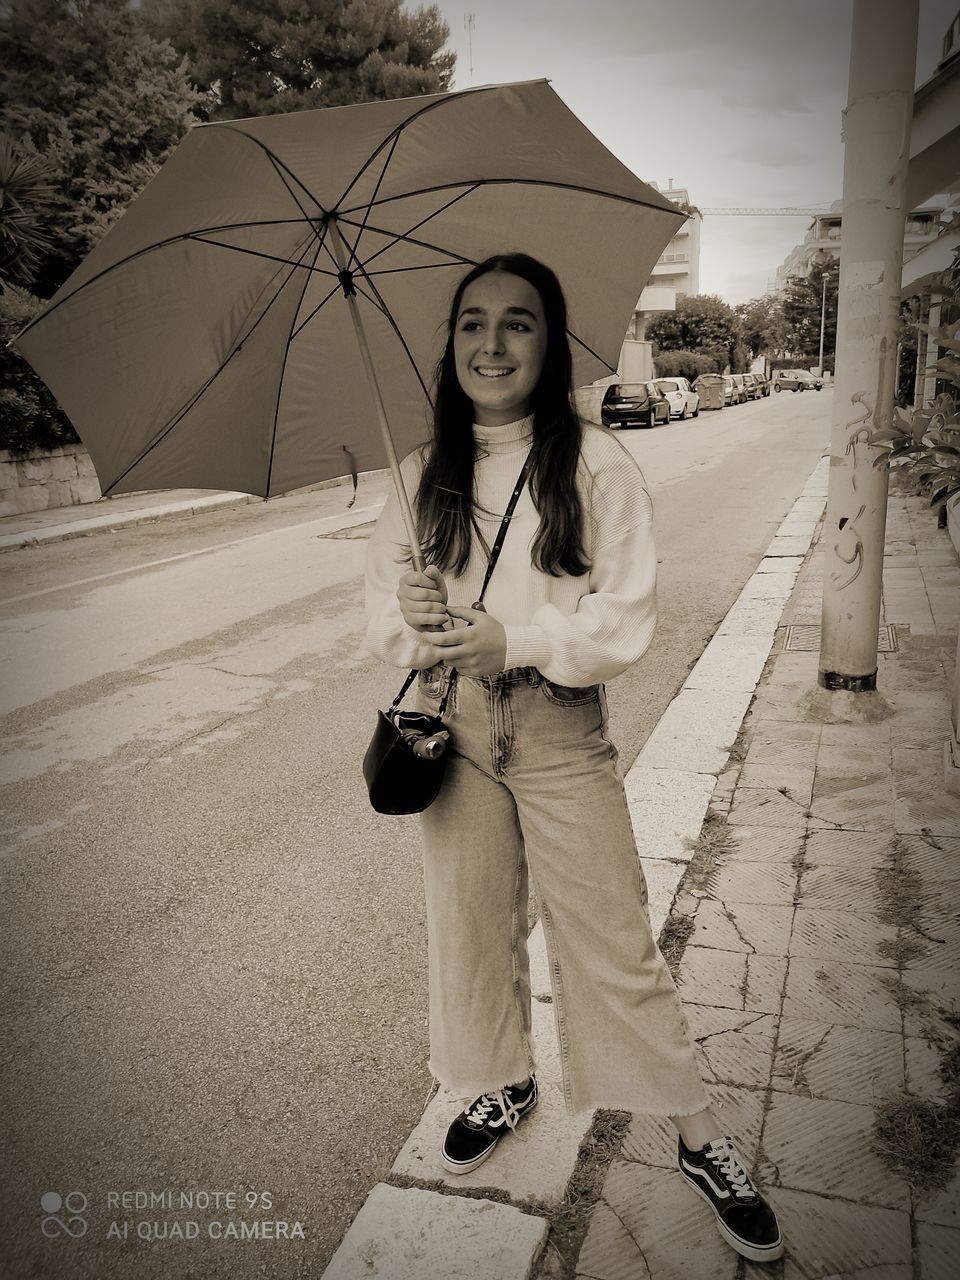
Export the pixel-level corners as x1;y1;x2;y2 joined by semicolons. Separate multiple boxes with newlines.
325;458;960;1280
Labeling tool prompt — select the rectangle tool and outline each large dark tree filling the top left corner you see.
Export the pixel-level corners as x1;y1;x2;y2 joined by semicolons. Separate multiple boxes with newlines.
0;0;198;297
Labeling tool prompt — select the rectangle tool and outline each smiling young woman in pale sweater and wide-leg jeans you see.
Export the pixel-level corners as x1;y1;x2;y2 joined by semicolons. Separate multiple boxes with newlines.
367;253;783;1261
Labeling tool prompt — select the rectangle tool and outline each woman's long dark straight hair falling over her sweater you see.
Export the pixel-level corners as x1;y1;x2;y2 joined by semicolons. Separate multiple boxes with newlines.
416;253;590;577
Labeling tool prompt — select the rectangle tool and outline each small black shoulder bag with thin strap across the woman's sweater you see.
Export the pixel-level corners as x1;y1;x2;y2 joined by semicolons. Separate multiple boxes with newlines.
364;454;531;814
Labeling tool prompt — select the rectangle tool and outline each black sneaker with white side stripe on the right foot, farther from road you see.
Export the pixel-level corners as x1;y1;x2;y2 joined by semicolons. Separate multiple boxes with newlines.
678;1138;783;1262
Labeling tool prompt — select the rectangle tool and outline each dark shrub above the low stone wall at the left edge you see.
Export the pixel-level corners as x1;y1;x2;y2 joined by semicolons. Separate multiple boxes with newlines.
0;284;79;456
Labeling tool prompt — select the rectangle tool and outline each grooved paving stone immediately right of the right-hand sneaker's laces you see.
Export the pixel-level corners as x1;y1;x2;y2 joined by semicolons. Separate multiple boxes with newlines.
763;1093;910;1210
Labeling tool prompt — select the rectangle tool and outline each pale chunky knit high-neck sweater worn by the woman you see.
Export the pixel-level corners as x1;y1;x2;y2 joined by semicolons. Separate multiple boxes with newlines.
366;417;657;686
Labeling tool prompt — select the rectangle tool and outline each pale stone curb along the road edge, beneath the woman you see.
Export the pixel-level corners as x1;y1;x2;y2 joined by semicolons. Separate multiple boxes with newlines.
323;451;829;1280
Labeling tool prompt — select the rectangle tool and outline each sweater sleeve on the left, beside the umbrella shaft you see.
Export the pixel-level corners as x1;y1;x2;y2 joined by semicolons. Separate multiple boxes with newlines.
365;452;434;671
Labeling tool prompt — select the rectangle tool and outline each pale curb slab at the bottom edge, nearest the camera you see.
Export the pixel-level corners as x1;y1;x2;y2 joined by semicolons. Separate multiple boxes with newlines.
324;1183;547;1280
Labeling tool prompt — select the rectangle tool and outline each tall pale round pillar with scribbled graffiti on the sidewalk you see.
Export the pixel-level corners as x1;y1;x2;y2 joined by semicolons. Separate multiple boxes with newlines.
819;0;919;694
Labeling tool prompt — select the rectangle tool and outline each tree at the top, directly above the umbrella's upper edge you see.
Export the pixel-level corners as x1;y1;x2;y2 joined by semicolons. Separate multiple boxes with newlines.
143;0;456;120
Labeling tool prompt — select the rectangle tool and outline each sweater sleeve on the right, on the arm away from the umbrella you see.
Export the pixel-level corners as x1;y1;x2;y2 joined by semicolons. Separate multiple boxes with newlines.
504;445;657;686
